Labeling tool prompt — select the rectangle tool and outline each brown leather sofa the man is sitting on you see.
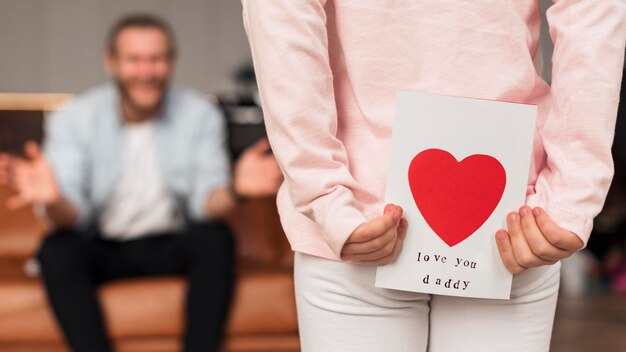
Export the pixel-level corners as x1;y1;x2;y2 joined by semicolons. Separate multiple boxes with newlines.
0;94;299;352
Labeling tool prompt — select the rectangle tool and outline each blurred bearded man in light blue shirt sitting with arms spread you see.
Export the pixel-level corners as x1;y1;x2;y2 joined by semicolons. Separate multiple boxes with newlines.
0;15;282;352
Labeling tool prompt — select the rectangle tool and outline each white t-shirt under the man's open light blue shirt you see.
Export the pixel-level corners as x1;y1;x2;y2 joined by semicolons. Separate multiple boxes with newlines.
100;121;183;240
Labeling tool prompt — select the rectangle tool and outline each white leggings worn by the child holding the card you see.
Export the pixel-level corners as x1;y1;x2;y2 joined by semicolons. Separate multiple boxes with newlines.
294;252;561;352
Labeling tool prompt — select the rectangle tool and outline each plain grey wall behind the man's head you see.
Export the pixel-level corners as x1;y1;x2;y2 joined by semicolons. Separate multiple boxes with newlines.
0;0;250;93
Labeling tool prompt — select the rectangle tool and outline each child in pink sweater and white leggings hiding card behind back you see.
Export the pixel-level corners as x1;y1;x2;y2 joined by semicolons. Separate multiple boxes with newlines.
243;0;626;352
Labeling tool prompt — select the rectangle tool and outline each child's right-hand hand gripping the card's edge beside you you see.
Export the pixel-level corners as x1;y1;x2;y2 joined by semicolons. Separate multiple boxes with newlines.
496;205;584;274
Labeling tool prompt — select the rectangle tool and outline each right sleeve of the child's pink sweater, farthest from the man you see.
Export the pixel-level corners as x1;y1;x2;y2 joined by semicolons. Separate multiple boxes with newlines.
527;0;626;245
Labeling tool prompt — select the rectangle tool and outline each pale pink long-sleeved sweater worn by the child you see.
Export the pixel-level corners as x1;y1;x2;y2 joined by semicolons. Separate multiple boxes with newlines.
243;0;626;259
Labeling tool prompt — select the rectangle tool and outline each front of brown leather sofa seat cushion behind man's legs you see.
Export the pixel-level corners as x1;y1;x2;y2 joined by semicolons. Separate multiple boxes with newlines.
0;272;297;342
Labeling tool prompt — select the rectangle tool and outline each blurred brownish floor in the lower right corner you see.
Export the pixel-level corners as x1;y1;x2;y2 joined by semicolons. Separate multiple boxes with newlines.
550;294;626;352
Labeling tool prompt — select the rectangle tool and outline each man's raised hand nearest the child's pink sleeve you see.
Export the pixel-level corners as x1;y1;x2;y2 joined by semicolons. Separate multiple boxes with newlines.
234;138;283;197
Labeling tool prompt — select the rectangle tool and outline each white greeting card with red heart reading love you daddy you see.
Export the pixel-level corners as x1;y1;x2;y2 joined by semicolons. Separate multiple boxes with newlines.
376;91;536;299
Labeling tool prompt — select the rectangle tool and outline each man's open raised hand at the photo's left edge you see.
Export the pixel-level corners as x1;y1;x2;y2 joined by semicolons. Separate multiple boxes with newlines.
0;142;60;210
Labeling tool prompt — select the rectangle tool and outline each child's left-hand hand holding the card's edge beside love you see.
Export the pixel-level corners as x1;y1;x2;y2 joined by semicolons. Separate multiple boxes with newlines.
341;204;408;265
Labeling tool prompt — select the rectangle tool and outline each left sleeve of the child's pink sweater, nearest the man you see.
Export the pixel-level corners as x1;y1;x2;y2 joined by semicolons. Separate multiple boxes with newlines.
242;0;367;256
